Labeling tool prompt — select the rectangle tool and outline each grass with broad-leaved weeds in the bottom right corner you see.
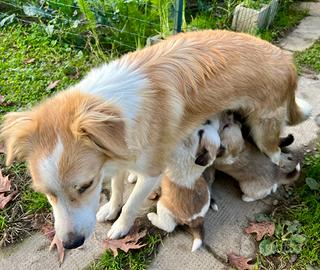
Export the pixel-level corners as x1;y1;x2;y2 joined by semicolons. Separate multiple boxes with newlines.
258;144;320;270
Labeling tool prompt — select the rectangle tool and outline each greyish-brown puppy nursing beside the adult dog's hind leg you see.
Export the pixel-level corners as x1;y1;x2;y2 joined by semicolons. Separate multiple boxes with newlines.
213;117;300;202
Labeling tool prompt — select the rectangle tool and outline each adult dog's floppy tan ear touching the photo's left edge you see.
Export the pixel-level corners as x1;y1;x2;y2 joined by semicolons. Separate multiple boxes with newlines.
0;112;35;166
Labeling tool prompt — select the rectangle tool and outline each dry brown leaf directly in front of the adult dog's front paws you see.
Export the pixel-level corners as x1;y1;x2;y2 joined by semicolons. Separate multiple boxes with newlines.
103;230;147;257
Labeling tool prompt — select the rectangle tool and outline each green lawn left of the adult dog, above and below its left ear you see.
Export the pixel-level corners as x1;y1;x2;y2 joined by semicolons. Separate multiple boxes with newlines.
0;24;99;246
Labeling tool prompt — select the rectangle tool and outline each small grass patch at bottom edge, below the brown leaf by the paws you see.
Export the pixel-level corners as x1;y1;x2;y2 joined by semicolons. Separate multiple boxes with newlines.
87;233;161;270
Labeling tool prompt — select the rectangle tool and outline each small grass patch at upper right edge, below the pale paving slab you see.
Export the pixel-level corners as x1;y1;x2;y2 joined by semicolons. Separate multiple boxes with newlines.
295;41;320;73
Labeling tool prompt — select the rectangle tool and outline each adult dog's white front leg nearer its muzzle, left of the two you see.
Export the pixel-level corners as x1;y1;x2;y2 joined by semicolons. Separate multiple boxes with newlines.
96;171;127;222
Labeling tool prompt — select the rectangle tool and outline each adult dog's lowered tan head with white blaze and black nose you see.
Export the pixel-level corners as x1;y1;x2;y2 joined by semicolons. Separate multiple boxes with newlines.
1;91;126;248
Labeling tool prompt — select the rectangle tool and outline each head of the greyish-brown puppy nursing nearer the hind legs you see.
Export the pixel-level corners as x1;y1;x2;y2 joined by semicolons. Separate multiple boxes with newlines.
218;118;244;158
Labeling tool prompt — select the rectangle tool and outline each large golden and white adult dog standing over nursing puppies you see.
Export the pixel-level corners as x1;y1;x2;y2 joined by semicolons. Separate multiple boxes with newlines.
1;31;309;248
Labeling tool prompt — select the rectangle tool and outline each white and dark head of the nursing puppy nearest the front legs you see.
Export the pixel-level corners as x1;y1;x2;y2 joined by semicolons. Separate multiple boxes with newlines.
195;120;220;167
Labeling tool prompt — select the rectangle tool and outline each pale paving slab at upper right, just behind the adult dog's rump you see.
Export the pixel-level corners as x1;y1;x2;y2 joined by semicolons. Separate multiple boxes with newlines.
279;16;320;51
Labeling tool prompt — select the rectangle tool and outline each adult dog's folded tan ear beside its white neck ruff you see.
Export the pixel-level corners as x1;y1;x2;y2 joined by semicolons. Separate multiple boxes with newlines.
71;102;127;159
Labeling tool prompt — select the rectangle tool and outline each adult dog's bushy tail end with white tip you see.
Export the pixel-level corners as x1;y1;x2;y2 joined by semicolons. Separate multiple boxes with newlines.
287;92;312;126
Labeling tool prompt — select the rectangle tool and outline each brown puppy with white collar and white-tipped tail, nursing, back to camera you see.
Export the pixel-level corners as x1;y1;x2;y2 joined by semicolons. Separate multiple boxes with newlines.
148;120;220;251
